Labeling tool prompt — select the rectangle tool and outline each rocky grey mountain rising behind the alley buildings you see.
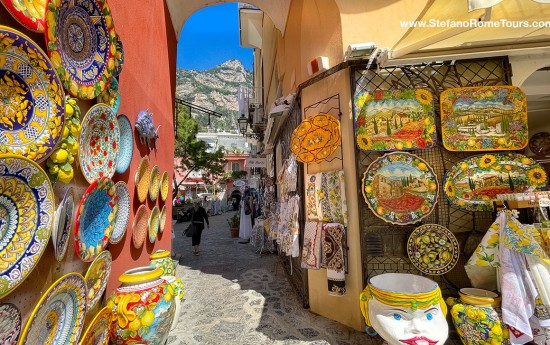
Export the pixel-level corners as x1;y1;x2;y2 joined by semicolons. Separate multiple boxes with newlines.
176;60;252;130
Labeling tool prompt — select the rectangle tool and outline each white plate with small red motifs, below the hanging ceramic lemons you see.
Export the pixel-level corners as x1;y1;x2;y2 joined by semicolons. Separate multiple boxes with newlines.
78;104;120;183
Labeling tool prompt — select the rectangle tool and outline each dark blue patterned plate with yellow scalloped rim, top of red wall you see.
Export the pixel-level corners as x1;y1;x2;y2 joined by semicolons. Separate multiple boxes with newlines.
45;0;116;99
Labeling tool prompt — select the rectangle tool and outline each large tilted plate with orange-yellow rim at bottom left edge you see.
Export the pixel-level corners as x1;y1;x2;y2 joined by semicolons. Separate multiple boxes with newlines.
19;273;86;345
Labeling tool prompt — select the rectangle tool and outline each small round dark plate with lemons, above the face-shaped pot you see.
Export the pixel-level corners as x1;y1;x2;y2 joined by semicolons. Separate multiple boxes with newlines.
407;224;460;275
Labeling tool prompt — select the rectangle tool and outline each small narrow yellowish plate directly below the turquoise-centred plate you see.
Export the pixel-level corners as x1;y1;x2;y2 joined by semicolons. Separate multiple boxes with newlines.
84;250;113;310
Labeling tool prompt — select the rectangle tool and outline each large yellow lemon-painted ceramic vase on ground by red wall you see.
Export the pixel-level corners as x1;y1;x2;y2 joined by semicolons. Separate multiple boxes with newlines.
107;266;177;345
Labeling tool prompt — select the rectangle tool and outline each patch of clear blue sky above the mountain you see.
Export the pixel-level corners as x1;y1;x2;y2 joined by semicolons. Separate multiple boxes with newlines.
177;3;252;71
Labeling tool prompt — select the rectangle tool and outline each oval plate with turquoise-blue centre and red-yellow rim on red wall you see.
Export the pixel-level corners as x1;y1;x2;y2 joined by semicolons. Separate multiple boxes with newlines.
74;177;118;262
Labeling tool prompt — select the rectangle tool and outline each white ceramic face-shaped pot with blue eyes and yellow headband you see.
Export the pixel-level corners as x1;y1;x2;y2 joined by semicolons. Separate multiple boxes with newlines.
360;273;449;345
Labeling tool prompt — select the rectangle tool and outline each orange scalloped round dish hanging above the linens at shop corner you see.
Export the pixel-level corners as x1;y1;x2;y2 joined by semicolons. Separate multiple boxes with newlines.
290;114;341;163
